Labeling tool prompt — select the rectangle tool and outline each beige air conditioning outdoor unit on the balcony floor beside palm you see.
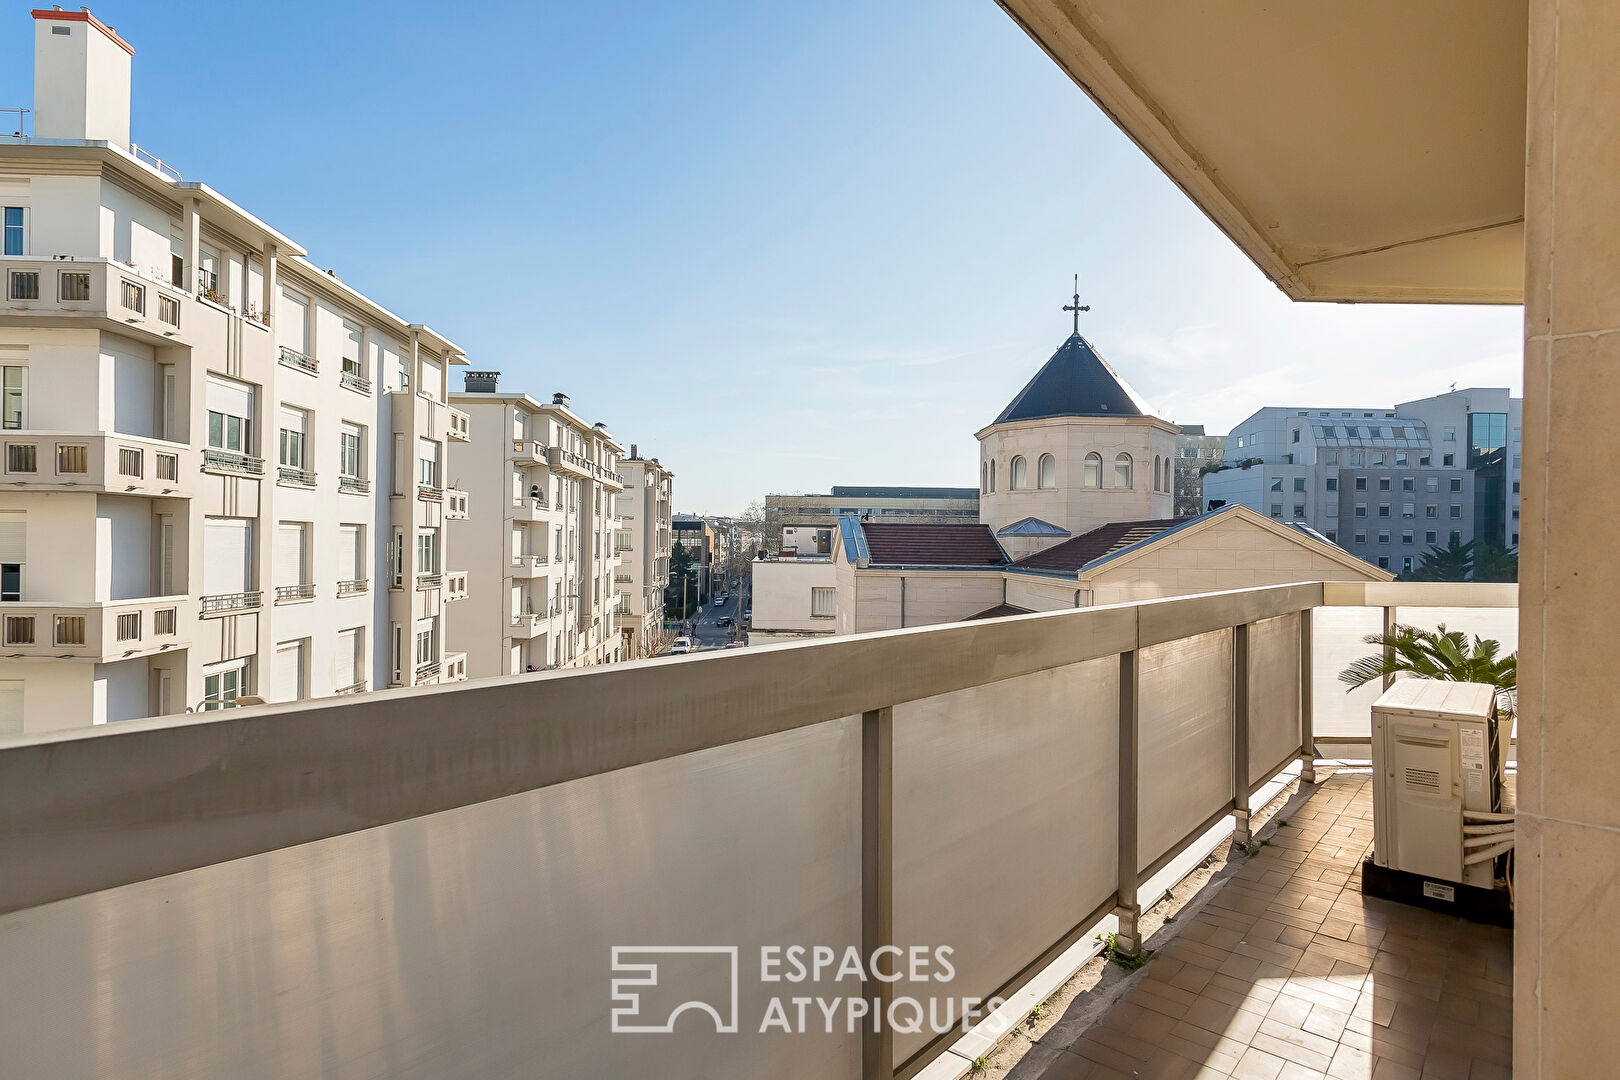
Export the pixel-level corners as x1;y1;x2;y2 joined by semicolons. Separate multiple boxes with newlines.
1362;678;1513;921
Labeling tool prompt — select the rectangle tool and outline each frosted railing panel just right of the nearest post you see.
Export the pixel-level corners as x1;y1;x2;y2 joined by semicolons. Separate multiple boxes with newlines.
894;657;1119;1062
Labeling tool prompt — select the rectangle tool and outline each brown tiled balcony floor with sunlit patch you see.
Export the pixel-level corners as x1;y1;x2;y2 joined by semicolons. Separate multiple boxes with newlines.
1008;771;1513;1080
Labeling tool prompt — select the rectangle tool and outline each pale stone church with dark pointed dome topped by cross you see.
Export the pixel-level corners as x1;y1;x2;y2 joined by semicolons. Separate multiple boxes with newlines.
833;295;1393;633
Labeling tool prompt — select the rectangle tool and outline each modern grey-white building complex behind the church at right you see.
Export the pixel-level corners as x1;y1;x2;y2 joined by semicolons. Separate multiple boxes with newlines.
1204;387;1523;573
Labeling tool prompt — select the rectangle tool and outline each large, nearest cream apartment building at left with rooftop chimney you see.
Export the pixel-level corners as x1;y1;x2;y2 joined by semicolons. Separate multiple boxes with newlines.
0;10;467;733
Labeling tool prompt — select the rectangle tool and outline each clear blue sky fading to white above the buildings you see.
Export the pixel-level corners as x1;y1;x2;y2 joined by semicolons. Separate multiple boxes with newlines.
0;0;1521;513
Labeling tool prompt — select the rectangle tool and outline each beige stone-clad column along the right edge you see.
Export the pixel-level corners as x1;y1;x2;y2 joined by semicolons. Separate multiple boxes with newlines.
1510;0;1620;1080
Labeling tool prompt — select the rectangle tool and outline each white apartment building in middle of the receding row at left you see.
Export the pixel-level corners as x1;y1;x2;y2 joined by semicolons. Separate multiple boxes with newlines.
450;371;624;678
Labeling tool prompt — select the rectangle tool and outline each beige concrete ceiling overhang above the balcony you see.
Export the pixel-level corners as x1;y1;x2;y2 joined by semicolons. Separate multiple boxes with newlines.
996;0;1528;303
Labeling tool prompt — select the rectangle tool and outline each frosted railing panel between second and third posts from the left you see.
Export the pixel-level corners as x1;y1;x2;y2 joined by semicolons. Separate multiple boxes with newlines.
1137;630;1233;868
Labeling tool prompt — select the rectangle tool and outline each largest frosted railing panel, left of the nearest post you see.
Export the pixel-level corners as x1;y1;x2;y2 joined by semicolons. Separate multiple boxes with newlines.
0;717;861;1080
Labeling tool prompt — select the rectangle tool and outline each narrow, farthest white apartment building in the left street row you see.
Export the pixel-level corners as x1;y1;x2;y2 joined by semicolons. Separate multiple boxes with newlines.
614;442;676;659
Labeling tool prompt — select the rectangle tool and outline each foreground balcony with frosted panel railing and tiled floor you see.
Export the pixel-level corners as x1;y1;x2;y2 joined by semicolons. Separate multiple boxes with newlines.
0;583;1516;1080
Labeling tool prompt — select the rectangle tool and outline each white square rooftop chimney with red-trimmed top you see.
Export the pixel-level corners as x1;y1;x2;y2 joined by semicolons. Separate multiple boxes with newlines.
34;8;134;151
